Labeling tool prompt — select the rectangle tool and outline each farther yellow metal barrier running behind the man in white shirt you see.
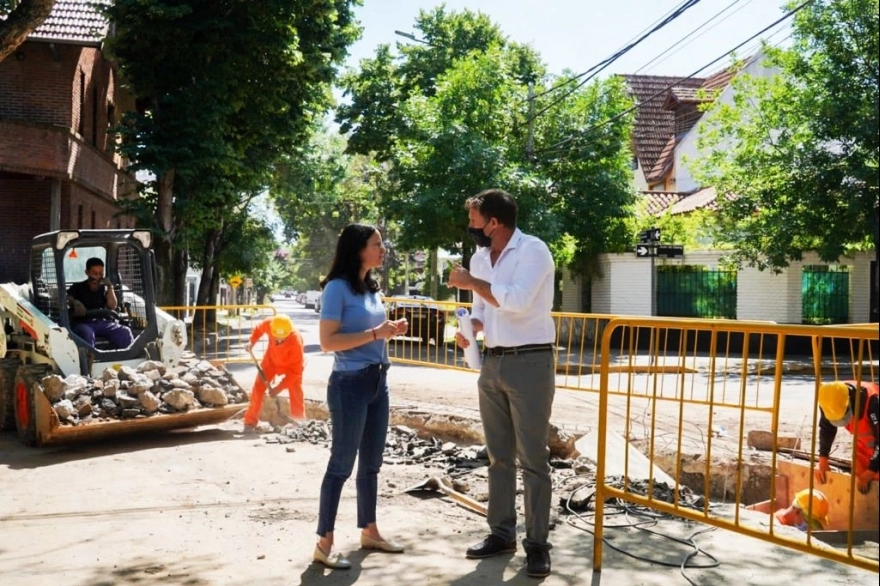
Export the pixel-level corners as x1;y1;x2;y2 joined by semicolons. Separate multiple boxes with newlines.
386;297;792;411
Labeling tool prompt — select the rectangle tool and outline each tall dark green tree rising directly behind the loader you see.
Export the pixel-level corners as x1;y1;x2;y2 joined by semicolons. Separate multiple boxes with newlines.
107;0;358;303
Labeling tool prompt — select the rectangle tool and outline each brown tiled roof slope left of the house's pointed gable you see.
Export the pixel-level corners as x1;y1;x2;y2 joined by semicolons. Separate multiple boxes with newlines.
623;75;705;172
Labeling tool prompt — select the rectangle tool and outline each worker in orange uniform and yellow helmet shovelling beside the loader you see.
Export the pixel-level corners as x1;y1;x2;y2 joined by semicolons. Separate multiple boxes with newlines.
244;315;306;431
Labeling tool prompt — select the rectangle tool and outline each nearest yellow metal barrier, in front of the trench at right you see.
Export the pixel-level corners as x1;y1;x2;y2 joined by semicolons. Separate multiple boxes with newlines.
593;318;880;573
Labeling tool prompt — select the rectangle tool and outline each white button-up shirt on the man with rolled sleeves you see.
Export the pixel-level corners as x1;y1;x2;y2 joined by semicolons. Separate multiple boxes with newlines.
470;228;556;348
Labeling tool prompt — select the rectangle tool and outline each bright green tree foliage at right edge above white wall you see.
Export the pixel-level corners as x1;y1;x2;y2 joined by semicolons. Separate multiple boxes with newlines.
695;0;880;270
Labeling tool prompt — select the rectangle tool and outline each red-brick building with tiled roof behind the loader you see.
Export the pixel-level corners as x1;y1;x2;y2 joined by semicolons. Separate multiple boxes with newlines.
0;0;135;283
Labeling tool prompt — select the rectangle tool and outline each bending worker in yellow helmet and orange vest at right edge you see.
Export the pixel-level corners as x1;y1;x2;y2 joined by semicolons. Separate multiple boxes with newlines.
815;381;880;494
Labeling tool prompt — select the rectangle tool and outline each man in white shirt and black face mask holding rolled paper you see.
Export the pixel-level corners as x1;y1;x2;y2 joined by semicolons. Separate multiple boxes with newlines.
449;189;556;577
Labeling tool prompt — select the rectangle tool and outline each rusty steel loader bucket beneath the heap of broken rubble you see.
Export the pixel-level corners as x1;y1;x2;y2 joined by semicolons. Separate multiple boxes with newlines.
16;368;248;446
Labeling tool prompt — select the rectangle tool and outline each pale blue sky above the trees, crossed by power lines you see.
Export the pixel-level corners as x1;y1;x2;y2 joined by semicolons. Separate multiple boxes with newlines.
346;0;791;77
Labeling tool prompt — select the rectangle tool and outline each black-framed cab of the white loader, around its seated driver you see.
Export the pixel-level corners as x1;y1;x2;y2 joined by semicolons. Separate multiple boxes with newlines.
30;230;158;363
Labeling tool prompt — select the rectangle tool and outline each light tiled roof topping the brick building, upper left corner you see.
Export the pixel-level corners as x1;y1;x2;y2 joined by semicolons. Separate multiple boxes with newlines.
28;0;111;45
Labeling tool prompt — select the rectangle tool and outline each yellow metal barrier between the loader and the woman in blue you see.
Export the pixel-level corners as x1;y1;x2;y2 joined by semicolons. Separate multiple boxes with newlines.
162;305;276;363
